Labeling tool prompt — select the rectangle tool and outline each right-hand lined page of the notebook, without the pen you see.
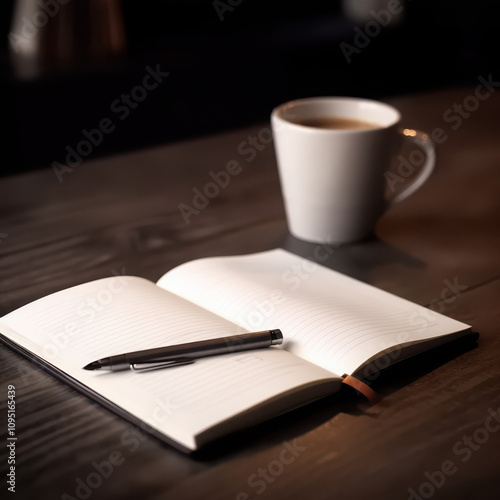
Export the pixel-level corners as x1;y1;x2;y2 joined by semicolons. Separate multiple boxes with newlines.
158;249;468;375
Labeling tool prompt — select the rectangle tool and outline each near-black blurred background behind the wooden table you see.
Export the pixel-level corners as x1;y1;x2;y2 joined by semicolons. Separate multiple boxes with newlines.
0;0;500;174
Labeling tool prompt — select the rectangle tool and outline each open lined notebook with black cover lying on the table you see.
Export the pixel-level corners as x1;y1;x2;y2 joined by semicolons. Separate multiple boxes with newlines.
0;249;470;450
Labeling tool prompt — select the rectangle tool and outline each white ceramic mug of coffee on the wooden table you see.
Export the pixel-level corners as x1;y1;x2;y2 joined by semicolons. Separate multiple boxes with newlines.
271;97;435;244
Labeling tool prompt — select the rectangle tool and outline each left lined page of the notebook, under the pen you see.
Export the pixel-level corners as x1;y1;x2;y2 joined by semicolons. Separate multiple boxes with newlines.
0;276;331;449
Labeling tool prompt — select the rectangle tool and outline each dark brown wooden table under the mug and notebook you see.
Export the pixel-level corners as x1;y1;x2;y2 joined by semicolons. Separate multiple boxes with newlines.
0;88;500;500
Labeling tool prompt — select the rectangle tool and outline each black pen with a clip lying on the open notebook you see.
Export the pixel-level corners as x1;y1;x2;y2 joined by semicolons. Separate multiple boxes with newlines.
83;330;283;371
